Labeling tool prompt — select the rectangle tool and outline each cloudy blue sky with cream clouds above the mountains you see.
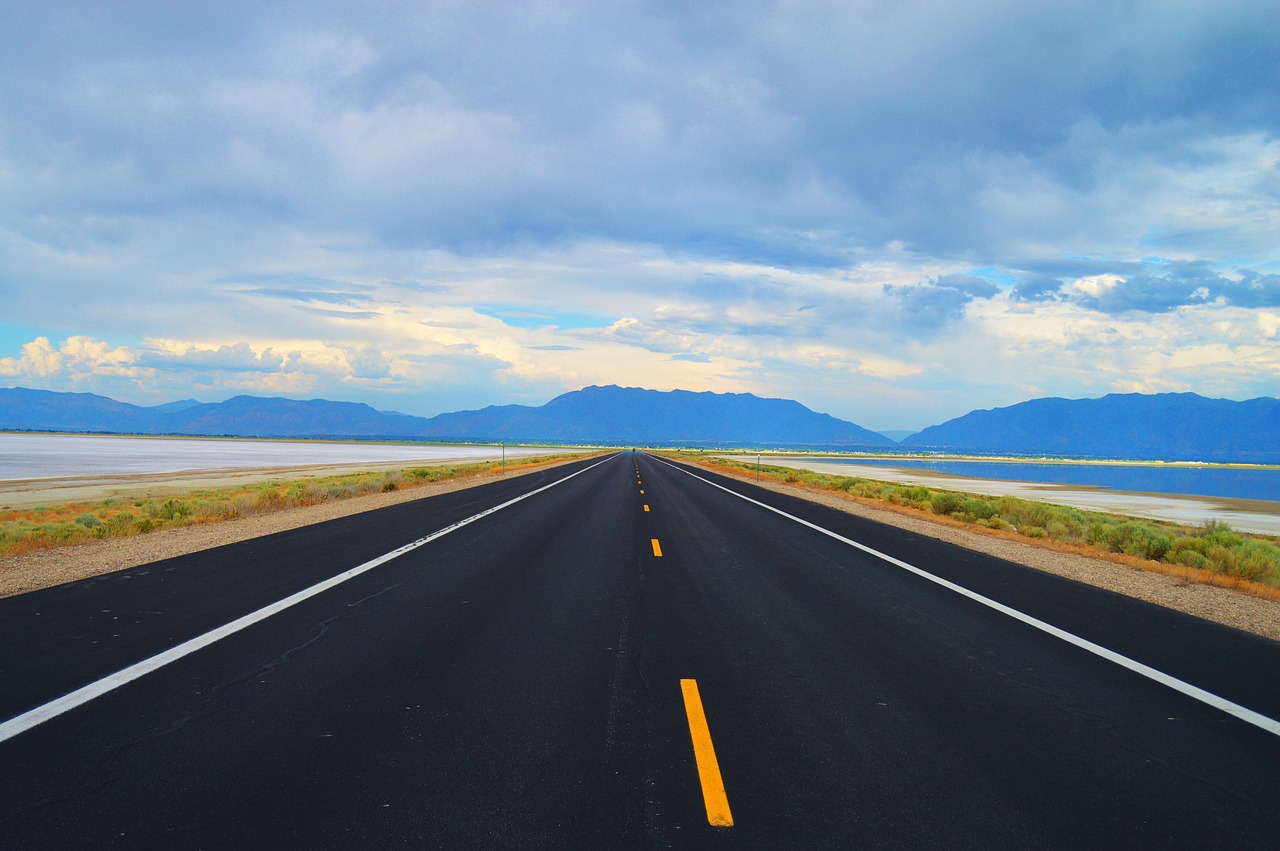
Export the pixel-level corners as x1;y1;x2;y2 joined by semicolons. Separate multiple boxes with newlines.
0;0;1280;430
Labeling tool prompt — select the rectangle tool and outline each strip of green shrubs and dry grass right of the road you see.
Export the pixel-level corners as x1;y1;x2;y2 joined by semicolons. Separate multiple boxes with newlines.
675;453;1280;599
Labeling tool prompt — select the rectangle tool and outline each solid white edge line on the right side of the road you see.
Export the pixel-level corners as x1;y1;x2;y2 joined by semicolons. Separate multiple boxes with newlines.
659;458;1280;736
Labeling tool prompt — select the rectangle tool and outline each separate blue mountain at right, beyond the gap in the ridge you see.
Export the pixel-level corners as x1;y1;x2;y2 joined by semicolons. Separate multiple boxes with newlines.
901;393;1280;463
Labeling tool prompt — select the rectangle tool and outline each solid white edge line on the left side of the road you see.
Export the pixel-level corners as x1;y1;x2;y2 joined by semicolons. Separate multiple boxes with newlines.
0;456;612;742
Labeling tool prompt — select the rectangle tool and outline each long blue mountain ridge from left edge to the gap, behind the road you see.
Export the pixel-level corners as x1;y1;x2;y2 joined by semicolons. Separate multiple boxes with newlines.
0;386;893;448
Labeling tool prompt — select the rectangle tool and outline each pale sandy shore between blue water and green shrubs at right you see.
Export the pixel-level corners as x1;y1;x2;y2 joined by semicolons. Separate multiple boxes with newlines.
724;456;1280;535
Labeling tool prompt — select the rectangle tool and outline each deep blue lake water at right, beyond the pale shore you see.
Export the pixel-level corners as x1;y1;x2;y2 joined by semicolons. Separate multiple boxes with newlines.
815;457;1280;502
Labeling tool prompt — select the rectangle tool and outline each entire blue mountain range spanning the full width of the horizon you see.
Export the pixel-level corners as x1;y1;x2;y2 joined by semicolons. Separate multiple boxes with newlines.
0;386;1280;463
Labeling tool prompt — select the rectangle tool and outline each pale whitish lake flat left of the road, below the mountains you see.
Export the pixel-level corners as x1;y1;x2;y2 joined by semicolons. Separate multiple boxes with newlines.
0;434;563;481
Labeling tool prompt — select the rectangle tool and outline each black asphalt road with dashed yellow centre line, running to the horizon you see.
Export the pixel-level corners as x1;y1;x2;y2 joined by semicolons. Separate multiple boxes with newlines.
0;453;1280;848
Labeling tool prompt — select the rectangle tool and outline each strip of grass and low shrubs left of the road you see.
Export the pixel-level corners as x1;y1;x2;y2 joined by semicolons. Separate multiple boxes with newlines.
0;456;577;555
